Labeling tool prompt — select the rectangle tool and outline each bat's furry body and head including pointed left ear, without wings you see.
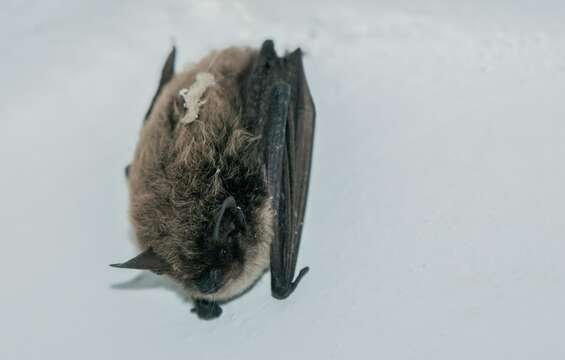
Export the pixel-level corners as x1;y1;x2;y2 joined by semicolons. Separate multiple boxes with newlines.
110;45;273;300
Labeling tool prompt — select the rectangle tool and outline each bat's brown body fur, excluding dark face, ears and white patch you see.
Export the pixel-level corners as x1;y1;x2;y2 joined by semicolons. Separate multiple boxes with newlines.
129;48;273;300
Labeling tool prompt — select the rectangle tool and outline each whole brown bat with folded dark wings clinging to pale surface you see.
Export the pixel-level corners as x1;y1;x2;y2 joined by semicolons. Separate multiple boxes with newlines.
111;40;315;319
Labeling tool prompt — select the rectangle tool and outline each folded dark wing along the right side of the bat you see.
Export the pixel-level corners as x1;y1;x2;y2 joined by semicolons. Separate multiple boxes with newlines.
244;41;315;299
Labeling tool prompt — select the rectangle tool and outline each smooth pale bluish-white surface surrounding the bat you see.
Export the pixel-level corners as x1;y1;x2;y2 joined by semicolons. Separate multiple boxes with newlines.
0;0;565;360
